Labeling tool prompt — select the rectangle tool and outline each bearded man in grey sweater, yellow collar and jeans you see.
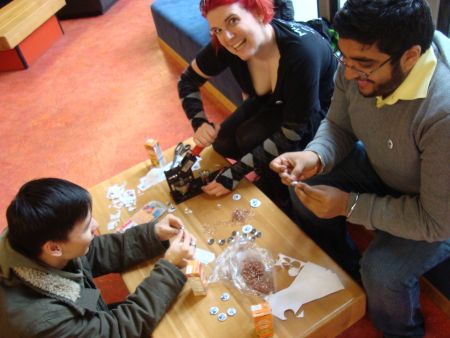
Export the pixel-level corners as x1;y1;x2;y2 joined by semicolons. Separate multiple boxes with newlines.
271;0;450;337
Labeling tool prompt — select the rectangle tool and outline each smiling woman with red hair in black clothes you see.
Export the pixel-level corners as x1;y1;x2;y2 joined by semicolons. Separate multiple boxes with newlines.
178;0;336;211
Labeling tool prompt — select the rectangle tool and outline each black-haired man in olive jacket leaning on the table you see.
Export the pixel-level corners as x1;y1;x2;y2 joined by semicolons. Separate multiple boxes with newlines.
0;178;195;338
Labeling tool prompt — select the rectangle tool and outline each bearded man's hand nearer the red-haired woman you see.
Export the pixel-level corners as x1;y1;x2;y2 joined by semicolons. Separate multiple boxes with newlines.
270;151;322;185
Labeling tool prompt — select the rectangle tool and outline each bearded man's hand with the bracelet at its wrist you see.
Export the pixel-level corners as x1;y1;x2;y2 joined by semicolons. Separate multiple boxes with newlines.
295;182;349;218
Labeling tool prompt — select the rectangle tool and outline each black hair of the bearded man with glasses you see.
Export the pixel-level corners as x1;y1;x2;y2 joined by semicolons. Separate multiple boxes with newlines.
333;0;434;63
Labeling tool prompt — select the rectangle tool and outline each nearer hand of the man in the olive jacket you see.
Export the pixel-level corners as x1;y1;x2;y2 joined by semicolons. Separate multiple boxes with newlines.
164;230;197;268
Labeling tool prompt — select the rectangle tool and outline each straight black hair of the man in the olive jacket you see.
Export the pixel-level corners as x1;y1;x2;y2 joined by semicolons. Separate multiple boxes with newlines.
6;178;92;258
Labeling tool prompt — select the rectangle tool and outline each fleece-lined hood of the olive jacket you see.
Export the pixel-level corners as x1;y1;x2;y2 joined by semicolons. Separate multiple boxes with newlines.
0;230;83;302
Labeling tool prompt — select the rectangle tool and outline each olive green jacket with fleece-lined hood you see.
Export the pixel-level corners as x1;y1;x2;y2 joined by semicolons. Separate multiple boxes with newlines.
0;223;186;338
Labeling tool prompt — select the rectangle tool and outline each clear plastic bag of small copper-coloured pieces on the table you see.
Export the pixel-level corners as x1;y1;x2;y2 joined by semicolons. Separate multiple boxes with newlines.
208;238;274;297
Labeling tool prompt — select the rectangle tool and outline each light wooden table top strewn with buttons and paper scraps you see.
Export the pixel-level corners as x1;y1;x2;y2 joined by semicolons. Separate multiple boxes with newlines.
90;143;366;338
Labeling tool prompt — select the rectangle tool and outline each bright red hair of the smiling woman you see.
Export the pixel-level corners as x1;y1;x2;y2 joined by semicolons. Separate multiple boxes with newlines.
200;0;274;23
